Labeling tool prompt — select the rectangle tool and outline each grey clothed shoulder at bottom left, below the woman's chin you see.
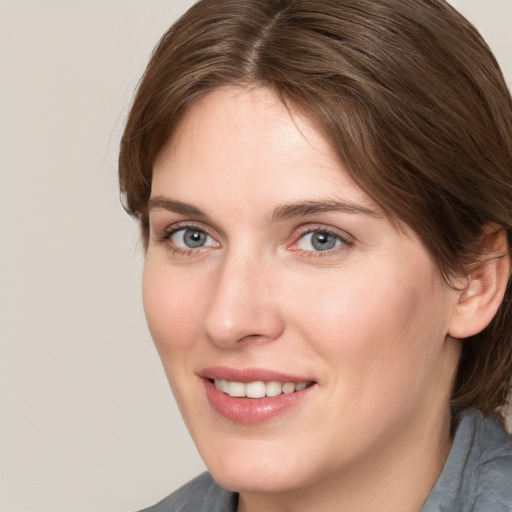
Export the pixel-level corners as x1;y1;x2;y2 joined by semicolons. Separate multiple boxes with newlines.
140;473;238;512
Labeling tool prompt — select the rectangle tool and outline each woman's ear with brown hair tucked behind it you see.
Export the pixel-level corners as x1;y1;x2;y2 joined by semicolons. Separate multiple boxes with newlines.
448;226;510;339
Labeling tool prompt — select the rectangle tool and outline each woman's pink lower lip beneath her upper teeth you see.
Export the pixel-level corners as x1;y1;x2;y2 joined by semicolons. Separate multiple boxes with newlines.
204;379;316;425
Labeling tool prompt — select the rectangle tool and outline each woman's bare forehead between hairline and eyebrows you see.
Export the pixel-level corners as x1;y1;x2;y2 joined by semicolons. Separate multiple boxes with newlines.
152;87;377;214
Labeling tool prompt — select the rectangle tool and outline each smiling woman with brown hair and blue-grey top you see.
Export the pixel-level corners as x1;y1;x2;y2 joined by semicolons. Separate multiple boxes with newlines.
120;0;512;512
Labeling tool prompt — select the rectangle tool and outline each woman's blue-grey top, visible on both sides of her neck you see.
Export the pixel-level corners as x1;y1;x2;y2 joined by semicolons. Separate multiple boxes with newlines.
140;411;512;512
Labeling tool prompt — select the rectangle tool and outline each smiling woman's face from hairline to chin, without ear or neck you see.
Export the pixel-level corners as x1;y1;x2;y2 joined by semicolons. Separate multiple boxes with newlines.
143;88;458;492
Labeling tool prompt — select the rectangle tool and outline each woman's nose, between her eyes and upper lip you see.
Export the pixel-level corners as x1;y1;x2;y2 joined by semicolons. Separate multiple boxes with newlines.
204;255;284;349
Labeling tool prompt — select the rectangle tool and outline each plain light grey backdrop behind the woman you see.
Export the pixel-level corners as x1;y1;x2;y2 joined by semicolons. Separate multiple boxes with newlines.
0;0;512;512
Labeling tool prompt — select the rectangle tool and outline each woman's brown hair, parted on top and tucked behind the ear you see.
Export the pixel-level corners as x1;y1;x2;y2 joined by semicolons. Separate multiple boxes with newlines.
119;0;512;414
